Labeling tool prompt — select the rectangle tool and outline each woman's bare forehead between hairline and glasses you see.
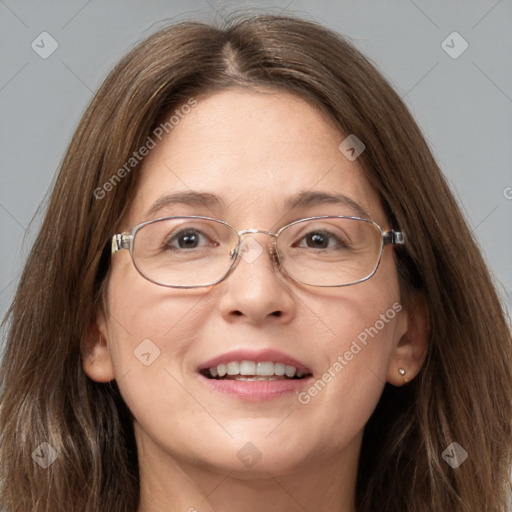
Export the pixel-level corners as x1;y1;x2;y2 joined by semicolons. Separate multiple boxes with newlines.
125;88;385;227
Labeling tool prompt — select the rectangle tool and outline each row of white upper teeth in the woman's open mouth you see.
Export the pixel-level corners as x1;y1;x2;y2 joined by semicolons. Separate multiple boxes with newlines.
205;360;305;381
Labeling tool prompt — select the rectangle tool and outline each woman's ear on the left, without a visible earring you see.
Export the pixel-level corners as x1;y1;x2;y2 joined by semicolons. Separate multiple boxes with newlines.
82;307;114;382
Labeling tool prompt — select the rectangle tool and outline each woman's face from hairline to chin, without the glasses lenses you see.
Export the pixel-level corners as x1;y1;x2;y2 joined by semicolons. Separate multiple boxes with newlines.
87;88;418;476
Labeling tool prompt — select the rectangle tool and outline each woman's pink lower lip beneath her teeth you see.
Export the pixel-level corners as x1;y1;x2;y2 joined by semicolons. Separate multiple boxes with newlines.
199;375;312;401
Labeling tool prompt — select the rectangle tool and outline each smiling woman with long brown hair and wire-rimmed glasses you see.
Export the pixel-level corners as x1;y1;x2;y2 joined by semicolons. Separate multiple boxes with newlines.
0;12;512;512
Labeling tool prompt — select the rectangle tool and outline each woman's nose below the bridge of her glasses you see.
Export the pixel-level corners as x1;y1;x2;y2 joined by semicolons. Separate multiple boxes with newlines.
217;231;296;325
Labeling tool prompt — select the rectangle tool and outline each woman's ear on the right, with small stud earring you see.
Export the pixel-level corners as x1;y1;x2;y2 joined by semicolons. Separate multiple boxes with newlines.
387;293;430;386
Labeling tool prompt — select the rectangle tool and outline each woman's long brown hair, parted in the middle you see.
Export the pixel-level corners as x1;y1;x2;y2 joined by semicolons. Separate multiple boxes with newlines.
0;15;512;512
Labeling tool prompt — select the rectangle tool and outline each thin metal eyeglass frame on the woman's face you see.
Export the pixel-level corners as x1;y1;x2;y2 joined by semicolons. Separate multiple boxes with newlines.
111;215;405;288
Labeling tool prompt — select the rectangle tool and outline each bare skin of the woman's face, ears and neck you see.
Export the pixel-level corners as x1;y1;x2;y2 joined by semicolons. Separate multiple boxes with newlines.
84;88;428;512
